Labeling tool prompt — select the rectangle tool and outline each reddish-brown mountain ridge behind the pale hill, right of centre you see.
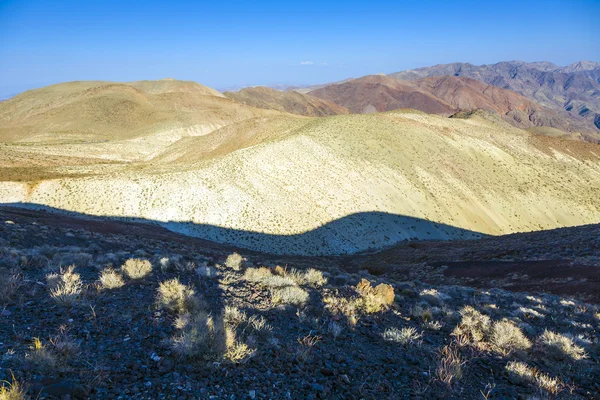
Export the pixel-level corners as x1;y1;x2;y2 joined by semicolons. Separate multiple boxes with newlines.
310;75;600;141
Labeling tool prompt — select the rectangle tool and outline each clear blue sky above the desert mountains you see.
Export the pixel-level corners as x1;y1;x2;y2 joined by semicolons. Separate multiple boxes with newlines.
0;0;600;96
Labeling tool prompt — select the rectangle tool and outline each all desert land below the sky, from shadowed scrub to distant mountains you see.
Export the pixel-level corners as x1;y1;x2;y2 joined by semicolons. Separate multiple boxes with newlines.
0;63;600;400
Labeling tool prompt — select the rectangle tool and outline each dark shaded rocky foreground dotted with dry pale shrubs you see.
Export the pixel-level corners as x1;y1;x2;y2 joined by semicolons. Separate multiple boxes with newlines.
0;208;600;400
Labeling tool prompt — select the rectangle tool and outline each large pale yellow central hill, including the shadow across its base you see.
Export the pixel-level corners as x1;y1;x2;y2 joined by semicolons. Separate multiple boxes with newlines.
0;110;600;254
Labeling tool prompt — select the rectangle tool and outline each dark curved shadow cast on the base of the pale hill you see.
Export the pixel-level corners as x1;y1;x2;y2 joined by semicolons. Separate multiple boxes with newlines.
1;203;486;255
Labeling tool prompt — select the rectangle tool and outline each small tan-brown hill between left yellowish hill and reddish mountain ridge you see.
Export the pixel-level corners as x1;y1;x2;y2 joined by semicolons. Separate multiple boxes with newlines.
224;86;348;117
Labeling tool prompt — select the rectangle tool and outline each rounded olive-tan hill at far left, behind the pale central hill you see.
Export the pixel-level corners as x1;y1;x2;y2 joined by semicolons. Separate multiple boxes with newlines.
0;80;277;161
